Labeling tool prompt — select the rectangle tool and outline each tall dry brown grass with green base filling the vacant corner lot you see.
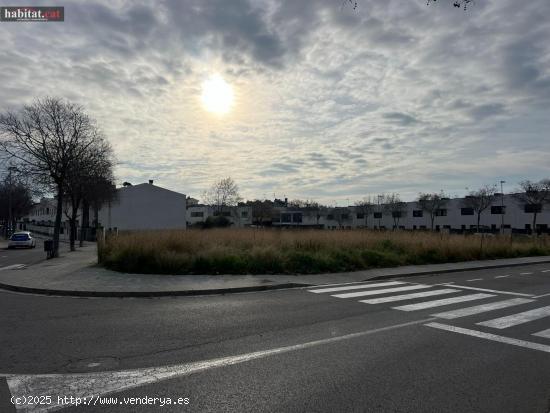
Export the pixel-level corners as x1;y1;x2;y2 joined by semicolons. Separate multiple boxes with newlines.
98;228;550;274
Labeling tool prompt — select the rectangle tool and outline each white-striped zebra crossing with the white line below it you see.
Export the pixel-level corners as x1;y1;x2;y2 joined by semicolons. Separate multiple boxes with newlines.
307;281;550;353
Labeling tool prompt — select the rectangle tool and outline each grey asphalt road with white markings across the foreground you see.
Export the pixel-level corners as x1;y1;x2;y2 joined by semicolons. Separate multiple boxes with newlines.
0;264;550;413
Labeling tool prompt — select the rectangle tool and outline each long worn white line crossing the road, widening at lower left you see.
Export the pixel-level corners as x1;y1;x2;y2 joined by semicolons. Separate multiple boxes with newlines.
0;318;434;412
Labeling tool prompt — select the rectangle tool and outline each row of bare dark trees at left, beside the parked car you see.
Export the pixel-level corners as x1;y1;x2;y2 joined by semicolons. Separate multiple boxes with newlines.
0;97;114;256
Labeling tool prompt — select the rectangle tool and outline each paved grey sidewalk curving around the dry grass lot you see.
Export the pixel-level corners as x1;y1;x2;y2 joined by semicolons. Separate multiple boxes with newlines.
0;245;550;297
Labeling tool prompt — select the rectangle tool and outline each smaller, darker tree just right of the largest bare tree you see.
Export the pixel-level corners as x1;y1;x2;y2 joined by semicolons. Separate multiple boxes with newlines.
65;134;114;251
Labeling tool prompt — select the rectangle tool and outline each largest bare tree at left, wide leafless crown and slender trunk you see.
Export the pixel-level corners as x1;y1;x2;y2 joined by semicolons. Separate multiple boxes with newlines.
0;98;99;257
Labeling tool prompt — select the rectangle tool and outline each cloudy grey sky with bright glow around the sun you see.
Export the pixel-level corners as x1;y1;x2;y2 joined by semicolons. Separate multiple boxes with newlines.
0;0;550;205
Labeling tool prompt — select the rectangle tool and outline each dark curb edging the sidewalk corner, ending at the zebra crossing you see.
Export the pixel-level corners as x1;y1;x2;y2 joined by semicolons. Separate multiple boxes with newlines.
0;283;311;298
